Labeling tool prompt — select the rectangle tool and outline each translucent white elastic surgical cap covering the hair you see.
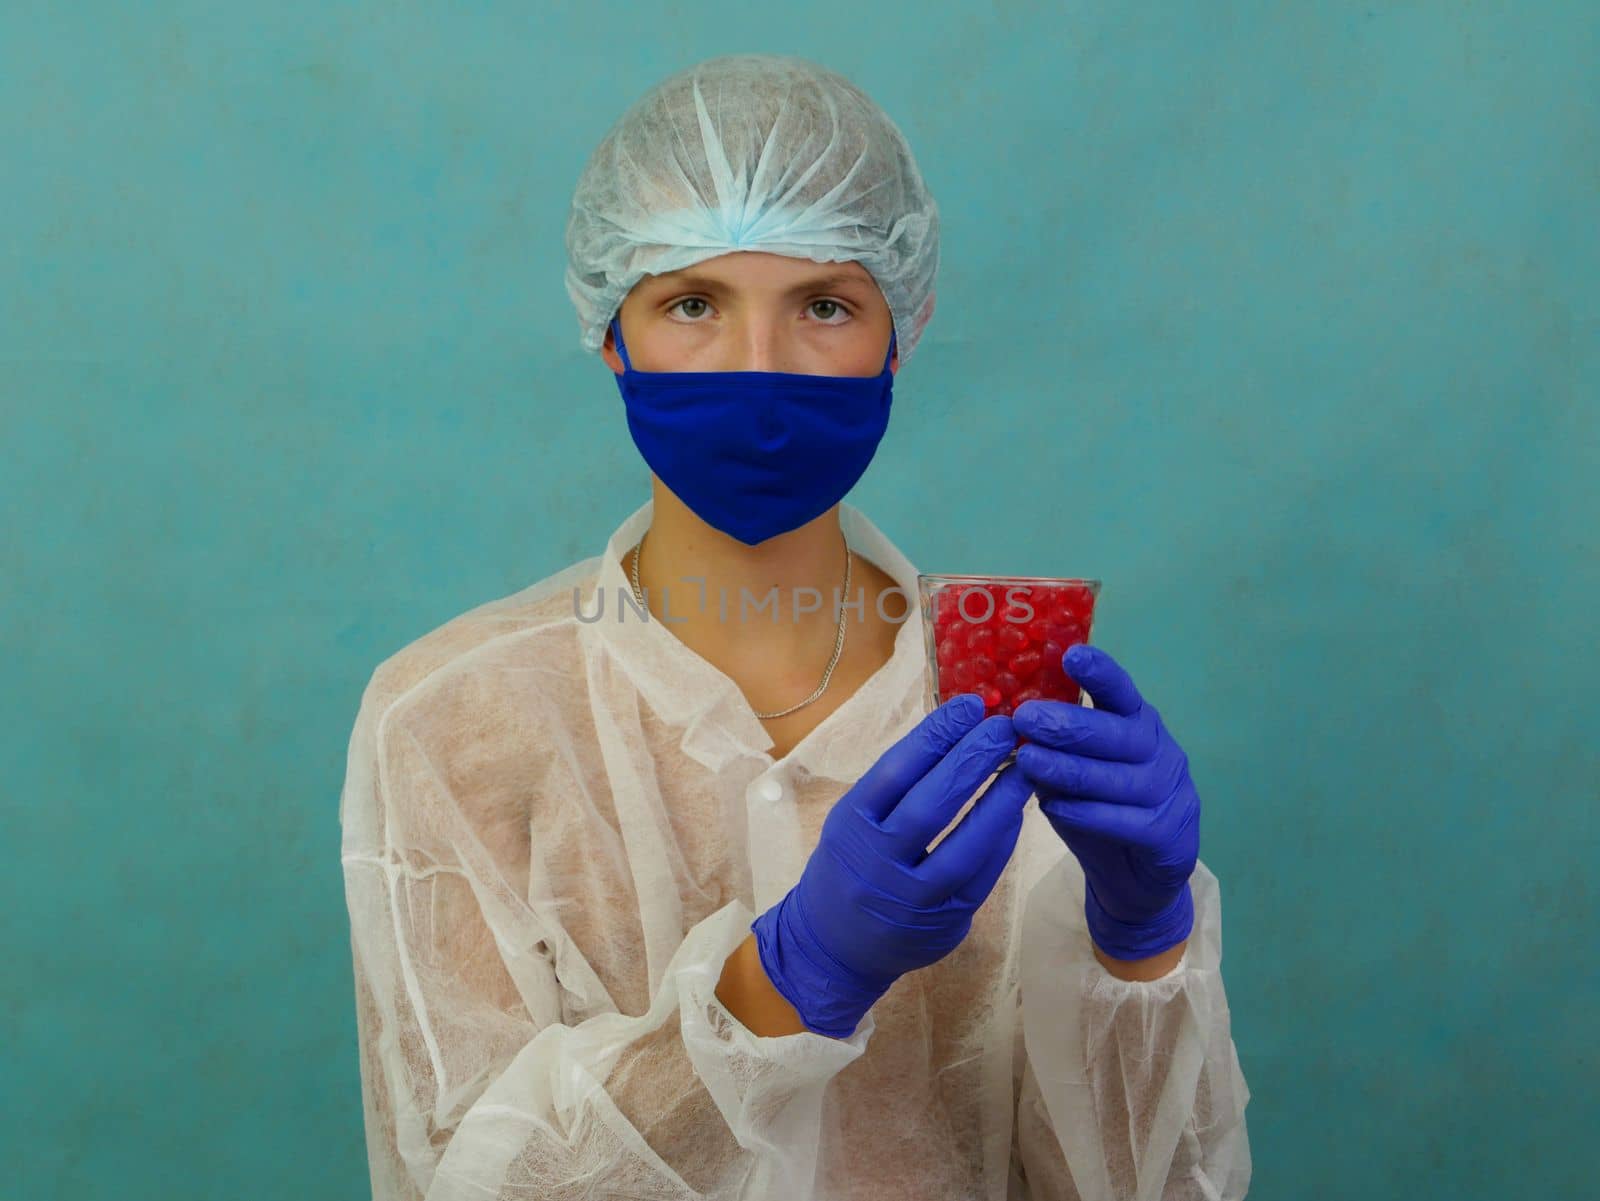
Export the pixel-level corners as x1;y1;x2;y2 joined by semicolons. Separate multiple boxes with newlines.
566;54;939;365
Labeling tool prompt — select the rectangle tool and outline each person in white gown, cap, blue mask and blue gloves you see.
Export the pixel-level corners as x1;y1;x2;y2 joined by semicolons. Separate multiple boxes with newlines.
339;54;1250;1201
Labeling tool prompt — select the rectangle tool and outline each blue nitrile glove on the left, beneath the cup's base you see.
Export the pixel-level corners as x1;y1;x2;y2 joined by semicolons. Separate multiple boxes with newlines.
750;692;1030;1038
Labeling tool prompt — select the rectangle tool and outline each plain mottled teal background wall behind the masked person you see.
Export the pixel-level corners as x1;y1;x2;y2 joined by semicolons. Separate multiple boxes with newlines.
0;0;1600;1201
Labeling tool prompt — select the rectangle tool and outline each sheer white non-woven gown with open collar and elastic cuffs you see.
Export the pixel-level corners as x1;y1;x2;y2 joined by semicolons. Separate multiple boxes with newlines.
341;504;1250;1201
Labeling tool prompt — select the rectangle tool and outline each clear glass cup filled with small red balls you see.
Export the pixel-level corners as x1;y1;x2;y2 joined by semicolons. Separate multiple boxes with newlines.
917;576;1101;718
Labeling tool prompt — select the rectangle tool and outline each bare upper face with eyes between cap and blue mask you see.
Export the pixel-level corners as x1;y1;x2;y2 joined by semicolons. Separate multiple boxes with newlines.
602;251;899;376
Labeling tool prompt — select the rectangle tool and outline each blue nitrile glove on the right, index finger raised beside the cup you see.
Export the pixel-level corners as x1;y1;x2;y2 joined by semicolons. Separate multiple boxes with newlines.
1013;643;1200;960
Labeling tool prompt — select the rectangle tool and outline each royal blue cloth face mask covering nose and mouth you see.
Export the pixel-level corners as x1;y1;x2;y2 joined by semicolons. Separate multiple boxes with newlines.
611;318;894;547
